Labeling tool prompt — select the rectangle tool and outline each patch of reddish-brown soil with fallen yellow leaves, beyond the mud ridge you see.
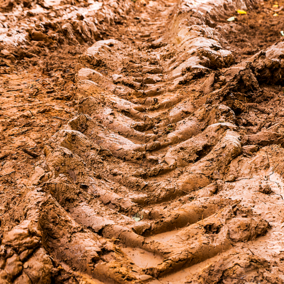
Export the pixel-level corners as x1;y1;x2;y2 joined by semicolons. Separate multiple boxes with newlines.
220;1;284;62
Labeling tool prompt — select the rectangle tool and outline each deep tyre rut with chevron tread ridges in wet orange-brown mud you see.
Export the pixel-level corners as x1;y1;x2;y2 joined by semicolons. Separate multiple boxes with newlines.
2;1;284;283
